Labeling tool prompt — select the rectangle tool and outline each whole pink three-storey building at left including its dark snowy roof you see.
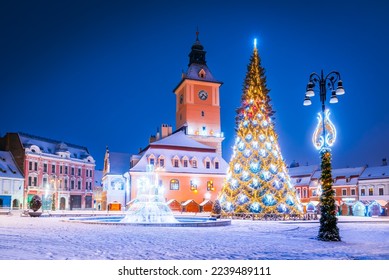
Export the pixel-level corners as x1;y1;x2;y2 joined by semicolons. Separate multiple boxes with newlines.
1;132;95;210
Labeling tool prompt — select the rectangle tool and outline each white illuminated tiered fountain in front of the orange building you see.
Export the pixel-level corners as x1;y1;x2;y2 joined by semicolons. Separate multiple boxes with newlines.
120;165;178;223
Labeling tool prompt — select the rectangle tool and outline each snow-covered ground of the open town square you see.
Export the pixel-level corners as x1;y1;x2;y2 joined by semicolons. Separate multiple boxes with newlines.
0;215;389;260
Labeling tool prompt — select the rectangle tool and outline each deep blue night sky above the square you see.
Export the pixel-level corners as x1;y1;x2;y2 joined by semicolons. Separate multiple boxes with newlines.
0;0;389;169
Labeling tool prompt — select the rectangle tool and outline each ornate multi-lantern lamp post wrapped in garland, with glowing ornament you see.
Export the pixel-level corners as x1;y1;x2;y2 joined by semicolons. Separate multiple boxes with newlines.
304;70;345;241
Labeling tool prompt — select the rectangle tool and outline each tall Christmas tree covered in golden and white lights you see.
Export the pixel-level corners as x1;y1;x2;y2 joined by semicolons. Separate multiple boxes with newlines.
220;40;302;217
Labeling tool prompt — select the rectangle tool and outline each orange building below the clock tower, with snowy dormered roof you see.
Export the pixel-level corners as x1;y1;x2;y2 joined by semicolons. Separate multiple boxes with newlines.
129;130;228;212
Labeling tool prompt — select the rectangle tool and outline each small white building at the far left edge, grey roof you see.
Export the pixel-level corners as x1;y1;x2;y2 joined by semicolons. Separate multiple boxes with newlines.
0;151;24;210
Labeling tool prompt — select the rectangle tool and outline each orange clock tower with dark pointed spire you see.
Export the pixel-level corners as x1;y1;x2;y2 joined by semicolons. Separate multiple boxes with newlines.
173;32;224;156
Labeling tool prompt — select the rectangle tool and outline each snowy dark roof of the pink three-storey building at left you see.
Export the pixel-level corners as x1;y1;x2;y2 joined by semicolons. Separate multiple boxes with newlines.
18;132;90;159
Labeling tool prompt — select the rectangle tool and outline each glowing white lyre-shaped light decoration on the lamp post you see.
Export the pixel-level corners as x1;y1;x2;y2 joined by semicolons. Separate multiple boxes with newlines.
312;109;336;150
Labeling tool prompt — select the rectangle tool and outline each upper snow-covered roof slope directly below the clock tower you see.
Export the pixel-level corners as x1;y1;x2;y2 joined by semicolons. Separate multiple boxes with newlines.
149;130;216;152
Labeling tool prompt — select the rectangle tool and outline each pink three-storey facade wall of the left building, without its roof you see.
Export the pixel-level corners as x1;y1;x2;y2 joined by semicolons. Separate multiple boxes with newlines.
24;153;95;210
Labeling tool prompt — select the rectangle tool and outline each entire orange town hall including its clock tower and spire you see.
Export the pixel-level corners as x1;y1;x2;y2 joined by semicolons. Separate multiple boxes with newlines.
129;33;228;212
